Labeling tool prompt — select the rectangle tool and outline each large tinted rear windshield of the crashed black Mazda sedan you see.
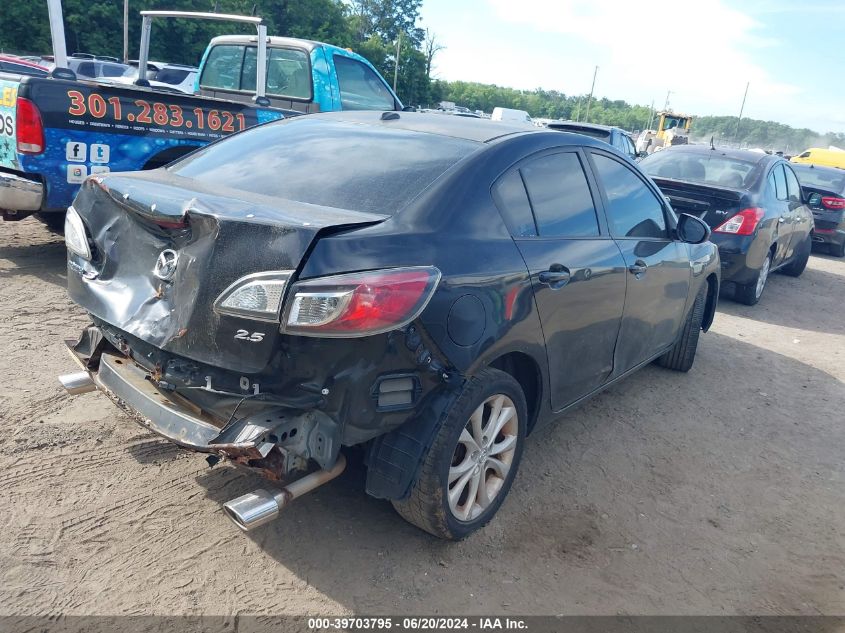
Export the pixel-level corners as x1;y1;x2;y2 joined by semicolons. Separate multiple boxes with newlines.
169;115;480;215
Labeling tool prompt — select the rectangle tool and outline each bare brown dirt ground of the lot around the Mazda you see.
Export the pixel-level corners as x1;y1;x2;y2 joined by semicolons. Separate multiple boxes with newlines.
0;219;845;615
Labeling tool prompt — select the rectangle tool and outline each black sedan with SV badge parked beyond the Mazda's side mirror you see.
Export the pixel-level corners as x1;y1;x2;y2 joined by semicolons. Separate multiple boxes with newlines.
640;145;813;305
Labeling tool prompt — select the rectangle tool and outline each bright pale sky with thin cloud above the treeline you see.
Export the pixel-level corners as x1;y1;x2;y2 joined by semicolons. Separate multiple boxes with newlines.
422;0;845;132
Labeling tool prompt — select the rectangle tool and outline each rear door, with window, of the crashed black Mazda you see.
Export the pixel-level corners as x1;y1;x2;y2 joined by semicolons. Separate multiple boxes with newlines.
493;149;627;410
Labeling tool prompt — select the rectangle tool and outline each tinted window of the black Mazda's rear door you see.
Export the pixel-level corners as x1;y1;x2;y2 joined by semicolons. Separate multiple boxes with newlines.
520;152;599;237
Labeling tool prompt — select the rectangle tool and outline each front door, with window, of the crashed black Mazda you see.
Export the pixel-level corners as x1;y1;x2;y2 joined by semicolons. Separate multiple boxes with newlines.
590;150;691;375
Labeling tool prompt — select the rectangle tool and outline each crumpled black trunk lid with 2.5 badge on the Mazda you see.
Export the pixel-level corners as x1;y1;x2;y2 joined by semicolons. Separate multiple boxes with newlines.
68;169;387;373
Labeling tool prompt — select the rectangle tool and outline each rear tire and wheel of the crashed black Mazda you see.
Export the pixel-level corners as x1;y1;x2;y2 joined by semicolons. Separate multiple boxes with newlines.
392;368;528;541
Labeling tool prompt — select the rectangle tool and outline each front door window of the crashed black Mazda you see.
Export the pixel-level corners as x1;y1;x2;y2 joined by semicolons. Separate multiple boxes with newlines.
593;154;668;239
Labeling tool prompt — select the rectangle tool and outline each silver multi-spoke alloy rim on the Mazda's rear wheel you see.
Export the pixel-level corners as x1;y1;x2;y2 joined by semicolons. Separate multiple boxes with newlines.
447;394;519;521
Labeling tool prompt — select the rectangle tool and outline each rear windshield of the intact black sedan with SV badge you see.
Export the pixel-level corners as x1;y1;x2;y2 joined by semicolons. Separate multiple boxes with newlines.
640;150;757;189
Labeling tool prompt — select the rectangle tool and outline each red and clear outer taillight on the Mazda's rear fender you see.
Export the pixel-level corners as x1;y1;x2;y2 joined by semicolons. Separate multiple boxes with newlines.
282;267;440;337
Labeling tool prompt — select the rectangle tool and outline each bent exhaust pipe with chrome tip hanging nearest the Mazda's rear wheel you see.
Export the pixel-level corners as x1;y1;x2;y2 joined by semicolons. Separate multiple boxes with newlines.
223;453;346;532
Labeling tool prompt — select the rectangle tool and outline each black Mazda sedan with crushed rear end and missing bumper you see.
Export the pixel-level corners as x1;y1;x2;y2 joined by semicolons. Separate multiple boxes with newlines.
61;112;720;539
